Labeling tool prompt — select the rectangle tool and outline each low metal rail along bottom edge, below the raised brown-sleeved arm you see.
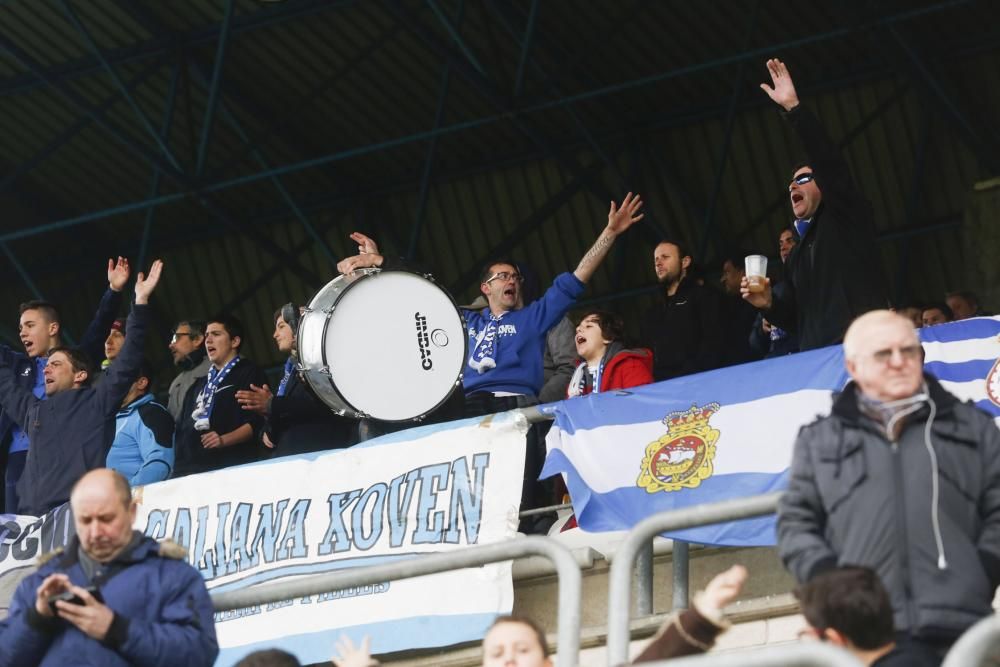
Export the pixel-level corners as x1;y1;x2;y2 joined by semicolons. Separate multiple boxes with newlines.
642;642;862;667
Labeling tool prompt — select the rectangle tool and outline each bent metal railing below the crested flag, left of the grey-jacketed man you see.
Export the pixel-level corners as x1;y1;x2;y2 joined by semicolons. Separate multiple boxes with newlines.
608;493;784;665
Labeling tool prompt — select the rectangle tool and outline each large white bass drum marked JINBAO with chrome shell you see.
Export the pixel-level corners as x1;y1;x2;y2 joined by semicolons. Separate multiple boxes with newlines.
297;269;468;422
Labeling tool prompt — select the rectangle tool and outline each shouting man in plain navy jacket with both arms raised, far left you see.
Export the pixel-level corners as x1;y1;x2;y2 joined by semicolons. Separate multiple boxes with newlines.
0;260;163;515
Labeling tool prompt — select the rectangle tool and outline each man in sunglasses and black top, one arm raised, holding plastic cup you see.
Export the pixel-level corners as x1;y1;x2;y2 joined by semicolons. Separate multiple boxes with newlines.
740;59;888;350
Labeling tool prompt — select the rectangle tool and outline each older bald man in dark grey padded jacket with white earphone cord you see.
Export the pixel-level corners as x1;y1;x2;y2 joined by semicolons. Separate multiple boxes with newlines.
778;310;1000;661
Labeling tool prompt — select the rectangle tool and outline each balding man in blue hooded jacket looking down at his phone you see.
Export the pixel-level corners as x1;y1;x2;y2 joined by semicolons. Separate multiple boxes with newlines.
0;469;219;667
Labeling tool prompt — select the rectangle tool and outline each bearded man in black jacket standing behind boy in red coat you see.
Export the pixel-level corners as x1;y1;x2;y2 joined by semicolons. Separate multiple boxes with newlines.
641;240;723;382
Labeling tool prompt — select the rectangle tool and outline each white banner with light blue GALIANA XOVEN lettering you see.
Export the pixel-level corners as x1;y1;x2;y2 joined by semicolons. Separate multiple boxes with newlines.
0;415;527;665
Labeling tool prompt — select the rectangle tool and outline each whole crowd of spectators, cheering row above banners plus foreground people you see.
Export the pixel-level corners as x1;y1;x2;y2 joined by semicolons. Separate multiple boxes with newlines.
0;60;1000;666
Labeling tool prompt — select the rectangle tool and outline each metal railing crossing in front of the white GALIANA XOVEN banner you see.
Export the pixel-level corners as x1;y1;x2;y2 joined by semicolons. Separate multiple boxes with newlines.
212;537;583;667
